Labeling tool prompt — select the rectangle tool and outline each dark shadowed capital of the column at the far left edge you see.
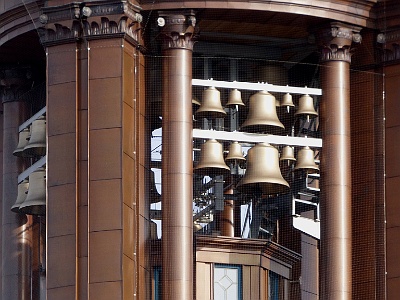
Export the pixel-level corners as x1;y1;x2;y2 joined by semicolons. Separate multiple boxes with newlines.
0;67;33;103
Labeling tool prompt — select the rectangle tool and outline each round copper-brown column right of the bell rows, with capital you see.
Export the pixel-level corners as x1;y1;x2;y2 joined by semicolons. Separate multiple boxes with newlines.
319;23;361;300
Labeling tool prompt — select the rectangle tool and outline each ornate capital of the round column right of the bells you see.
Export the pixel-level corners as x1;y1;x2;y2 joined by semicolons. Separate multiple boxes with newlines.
317;22;362;63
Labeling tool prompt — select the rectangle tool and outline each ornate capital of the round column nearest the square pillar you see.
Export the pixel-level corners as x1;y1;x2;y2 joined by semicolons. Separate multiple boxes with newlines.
157;11;196;50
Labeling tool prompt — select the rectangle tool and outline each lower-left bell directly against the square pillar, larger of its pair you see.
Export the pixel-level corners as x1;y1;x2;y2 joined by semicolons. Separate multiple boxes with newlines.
19;168;46;215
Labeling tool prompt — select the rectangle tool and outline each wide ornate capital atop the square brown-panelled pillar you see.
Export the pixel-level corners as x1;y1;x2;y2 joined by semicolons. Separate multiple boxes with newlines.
39;0;143;45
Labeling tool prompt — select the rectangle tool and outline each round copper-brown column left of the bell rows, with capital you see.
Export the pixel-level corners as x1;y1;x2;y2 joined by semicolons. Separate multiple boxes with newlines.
158;11;196;300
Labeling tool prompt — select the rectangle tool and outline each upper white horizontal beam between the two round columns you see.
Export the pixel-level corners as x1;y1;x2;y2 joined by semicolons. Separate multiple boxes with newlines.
192;79;322;95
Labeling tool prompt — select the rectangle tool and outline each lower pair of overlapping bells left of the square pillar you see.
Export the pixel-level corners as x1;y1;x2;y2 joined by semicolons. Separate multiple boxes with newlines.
11;168;46;215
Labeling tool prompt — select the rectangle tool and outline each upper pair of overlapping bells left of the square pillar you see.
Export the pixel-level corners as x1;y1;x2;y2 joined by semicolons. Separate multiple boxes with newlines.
13;116;46;157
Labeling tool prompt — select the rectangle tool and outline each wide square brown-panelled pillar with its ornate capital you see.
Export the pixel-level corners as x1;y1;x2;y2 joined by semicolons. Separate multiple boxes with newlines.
40;1;147;300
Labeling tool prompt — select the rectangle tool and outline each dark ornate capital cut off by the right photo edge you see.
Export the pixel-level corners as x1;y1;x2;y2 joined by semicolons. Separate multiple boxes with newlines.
376;28;400;63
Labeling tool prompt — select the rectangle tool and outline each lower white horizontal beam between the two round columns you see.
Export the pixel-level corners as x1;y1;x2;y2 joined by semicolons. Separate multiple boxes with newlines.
193;129;322;148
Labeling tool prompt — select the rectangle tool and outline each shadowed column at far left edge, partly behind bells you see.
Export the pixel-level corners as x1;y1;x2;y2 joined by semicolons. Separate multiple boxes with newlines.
0;68;33;300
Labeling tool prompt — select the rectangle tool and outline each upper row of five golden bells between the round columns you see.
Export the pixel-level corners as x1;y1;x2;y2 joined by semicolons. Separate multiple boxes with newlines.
195;87;318;132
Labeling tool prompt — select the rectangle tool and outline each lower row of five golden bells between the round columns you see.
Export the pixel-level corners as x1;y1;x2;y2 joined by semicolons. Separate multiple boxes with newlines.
194;139;319;194
